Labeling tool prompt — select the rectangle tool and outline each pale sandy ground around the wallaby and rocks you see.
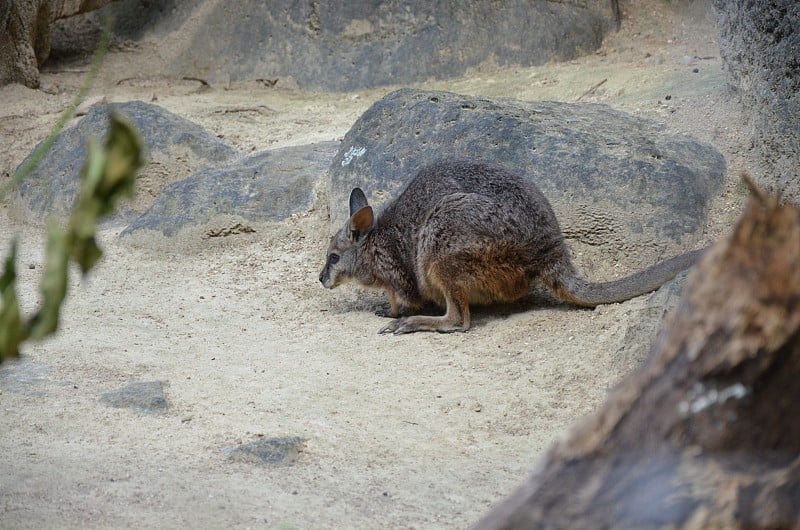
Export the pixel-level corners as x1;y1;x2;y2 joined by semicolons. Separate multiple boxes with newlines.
0;1;760;528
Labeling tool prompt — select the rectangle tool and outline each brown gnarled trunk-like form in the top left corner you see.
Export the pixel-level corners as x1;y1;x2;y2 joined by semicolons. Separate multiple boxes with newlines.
0;0;111;88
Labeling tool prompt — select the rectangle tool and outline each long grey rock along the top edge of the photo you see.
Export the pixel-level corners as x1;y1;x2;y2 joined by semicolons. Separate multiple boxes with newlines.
98;0;618;90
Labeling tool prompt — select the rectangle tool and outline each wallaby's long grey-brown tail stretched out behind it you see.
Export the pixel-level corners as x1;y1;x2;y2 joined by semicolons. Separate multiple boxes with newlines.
544;249;706;307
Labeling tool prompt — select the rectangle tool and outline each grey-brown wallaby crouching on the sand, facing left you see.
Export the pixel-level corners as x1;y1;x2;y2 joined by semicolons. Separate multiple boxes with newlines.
319;161;704;334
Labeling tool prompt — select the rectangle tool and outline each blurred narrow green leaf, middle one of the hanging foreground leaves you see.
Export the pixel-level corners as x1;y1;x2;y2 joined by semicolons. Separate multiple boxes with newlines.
29;222;69;340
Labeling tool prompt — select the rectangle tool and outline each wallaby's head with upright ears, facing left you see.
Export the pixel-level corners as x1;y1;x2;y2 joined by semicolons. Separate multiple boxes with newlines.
319;188;375;289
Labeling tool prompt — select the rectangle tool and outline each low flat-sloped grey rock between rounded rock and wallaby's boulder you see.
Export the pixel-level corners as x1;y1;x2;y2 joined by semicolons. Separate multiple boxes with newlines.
123;142;339;236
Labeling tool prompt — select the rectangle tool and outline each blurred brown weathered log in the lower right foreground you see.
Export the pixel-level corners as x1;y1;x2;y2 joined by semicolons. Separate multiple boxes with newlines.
476;181;800;530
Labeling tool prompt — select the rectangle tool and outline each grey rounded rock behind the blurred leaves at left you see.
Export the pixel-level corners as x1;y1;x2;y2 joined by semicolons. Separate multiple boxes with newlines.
15;101;237;217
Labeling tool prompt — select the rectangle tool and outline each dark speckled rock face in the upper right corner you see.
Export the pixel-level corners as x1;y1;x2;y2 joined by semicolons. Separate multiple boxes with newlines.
714;0;800;202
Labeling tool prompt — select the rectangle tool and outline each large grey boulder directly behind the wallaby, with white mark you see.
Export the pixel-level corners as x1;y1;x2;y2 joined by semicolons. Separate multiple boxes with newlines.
329;89;725;271
